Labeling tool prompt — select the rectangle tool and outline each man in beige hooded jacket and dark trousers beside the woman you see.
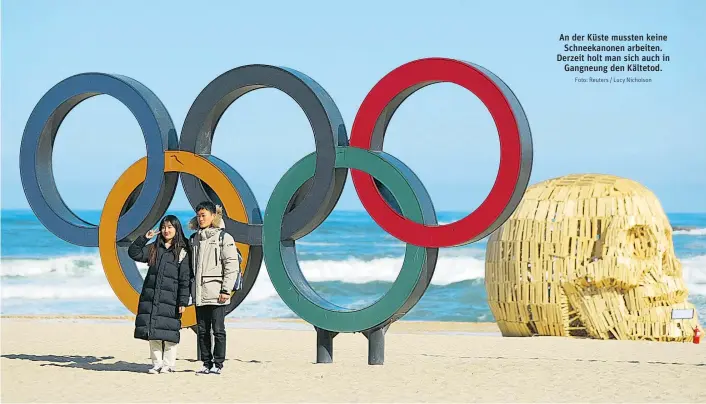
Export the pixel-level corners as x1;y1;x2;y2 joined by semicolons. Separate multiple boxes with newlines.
189;201;240;374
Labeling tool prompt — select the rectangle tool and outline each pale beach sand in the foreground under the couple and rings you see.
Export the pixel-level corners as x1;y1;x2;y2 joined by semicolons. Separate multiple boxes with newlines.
0;317;706;403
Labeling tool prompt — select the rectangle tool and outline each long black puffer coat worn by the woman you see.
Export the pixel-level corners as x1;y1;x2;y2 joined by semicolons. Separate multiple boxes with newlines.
128;236;191;343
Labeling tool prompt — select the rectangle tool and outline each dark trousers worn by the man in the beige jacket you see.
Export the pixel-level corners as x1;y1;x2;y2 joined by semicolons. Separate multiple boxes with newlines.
196;305;226;369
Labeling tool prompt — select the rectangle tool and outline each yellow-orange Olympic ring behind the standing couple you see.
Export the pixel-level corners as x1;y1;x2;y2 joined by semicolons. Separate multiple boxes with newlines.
98;151;250;328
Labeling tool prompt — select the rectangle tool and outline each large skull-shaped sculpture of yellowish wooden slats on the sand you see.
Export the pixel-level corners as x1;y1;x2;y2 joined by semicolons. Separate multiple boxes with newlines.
485;175;701;341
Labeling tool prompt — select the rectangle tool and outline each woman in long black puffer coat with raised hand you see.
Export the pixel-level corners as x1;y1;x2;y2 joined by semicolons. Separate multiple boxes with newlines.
128;215;191;374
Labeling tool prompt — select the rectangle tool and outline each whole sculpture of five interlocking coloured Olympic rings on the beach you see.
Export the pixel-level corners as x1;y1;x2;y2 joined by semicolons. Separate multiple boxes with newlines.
20;58;533;364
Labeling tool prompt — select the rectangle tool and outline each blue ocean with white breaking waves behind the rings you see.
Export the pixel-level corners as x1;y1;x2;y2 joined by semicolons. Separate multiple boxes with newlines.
0;210;706;322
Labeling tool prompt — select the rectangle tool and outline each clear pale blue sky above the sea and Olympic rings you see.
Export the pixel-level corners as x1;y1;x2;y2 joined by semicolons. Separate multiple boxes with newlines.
1;0;706;212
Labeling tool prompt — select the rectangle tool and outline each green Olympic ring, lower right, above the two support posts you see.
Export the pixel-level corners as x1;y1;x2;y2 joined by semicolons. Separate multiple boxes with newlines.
263;147;439;332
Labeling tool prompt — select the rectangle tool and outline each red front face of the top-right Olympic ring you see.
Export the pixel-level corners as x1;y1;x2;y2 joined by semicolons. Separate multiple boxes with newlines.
350;58;522;247
